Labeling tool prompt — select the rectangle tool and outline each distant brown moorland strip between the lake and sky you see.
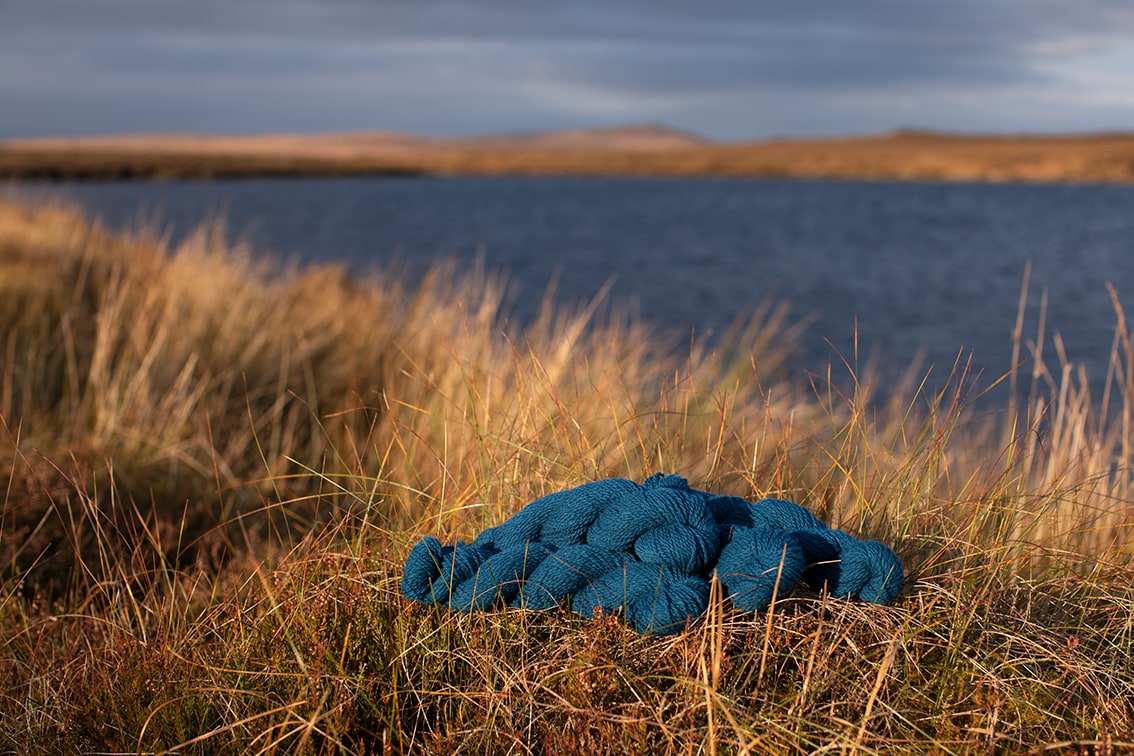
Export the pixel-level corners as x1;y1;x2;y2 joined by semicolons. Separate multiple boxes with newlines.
0;126;1134;182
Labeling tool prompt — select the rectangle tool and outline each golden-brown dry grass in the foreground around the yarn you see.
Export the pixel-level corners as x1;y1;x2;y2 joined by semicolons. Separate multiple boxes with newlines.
0;198;1134;754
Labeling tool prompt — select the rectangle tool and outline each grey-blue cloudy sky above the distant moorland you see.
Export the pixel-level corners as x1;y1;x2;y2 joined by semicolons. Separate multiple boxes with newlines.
0;0;1134;139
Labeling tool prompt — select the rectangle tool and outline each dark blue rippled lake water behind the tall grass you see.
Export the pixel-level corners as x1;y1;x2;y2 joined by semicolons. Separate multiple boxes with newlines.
13;178;1134;401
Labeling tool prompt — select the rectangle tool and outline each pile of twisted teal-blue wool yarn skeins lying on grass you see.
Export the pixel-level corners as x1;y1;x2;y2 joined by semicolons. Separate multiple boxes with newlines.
401;473;904;635
